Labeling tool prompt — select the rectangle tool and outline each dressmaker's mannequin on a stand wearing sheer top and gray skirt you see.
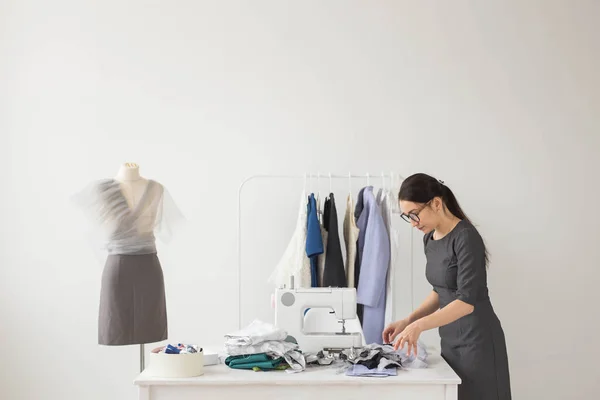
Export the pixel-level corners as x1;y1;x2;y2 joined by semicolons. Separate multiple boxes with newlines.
74;163;182;369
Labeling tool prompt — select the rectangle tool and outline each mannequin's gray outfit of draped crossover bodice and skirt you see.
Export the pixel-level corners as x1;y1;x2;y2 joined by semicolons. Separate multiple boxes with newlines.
98;179;168;346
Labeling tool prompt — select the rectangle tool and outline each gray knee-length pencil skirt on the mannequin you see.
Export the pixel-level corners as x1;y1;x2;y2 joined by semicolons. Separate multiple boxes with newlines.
98;253;167;346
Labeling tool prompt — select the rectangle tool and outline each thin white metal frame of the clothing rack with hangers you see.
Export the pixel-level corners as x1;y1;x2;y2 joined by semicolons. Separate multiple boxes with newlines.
237;172;414;329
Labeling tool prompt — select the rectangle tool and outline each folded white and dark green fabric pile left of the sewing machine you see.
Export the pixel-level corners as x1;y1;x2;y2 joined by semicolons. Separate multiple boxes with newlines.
225;320;306;372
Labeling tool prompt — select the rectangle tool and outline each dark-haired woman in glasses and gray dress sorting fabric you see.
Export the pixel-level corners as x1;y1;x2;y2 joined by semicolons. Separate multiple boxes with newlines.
383;174;511;400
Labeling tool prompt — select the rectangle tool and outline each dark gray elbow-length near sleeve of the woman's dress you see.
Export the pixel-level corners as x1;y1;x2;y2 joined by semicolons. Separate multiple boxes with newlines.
454;229;486;305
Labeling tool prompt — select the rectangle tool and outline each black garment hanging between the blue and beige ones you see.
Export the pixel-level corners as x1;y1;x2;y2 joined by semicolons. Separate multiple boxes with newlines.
321;193;348;287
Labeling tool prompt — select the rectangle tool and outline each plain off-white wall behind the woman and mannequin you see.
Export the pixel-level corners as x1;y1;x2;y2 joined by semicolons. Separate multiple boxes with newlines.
0;0;600;400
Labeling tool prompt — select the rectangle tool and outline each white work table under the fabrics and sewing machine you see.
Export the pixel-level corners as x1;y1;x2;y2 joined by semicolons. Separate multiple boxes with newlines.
134;354;461;400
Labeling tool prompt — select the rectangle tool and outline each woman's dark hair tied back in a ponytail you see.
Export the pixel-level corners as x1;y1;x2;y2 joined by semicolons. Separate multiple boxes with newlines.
398;173;489;265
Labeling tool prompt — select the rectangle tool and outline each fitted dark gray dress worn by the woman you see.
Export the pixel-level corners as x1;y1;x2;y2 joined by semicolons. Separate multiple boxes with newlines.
423;220;511;400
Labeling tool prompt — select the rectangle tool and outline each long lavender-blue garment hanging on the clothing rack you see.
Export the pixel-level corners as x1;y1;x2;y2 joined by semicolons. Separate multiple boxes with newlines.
356;186;390;344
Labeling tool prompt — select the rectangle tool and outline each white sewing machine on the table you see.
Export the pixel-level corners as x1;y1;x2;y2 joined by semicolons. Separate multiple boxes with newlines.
275;288;364;353
